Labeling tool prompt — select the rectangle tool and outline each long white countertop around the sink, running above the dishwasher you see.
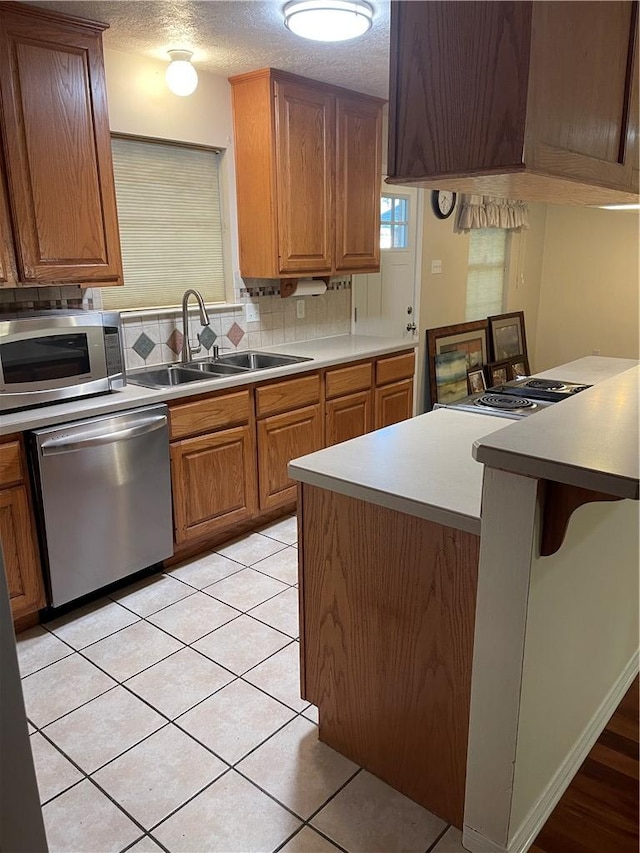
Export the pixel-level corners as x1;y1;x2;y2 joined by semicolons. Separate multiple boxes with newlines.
0;335;417;435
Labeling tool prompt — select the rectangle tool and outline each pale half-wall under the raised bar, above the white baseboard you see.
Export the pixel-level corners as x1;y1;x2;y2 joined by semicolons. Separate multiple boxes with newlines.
509;500;638;839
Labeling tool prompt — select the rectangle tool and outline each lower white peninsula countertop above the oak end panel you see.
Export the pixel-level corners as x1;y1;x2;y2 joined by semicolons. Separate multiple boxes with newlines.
289;409;513;534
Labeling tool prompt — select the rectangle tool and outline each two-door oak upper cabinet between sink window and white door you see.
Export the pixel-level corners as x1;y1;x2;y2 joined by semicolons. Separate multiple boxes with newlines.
230;68;384;278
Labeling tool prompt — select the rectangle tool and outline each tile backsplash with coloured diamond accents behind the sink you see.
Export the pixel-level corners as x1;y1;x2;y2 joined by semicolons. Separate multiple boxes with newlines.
0;279;351;370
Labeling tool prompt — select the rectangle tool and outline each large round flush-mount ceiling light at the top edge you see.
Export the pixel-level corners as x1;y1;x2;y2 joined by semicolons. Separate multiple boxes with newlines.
284;0;373;41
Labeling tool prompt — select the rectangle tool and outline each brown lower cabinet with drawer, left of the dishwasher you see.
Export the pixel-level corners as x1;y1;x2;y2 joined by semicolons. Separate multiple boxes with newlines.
0;436;45;620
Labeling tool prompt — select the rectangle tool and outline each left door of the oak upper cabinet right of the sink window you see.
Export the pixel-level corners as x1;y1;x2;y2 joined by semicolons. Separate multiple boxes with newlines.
275;82;335;273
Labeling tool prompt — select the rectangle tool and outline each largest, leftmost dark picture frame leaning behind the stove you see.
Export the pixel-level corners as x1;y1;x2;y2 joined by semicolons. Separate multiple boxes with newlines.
425;320;489;411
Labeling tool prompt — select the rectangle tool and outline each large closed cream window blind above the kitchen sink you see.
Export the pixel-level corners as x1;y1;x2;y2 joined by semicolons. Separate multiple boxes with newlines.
102;138;225;310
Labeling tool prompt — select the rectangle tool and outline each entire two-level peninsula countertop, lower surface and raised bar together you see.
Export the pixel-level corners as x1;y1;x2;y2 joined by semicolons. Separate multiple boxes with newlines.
289;356;640;533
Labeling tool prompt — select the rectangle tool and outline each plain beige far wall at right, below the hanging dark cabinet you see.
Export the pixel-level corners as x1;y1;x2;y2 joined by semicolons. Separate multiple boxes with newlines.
536;205;638;370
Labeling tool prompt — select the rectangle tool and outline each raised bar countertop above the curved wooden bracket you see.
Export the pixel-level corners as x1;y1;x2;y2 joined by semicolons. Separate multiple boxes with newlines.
473;367;640;500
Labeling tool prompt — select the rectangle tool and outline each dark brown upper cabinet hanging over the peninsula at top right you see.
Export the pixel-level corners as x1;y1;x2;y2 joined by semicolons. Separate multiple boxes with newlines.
389;0;638;204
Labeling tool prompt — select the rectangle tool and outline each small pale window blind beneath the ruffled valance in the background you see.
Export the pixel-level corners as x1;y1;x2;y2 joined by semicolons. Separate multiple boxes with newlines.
466;228;508;321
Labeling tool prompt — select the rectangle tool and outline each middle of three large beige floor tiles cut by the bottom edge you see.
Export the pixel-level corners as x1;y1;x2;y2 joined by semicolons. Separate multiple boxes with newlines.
153;770;300;853
